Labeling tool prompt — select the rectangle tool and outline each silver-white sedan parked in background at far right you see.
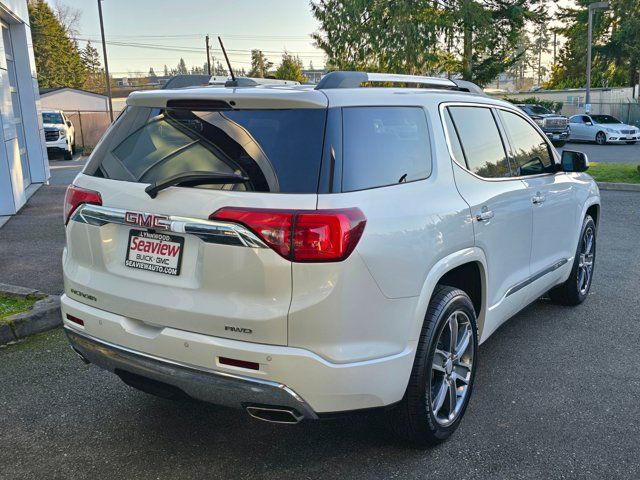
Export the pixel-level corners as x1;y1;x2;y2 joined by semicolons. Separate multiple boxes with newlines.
569;115;640;145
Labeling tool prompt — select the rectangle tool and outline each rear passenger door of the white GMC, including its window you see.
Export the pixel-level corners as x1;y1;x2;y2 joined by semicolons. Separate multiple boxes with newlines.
442;104;532;338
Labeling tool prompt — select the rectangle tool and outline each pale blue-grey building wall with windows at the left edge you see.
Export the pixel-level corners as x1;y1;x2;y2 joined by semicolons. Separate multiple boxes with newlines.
0;0;50;215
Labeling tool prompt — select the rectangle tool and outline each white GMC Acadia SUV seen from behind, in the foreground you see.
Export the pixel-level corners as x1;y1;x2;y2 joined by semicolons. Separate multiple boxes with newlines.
62;72;600;444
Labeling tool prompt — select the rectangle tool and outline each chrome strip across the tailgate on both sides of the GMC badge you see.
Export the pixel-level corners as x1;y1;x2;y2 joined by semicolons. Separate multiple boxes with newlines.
71;204;268;248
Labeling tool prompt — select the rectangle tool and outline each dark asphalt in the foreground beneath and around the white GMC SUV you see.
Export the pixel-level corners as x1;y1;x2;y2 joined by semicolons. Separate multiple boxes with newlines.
0;188;640;479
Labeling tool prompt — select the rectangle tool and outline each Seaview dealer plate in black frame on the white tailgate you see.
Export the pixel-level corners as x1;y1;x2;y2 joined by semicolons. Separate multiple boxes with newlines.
124;229;184;277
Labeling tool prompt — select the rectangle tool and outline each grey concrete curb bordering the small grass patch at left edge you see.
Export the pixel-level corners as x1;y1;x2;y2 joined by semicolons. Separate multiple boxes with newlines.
0;283;62;345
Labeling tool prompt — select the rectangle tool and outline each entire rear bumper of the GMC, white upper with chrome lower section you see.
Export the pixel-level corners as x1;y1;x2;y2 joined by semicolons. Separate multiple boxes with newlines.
60;295;415;418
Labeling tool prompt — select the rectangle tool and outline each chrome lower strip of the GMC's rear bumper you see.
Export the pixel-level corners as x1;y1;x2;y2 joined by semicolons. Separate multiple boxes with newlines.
65;326;317;419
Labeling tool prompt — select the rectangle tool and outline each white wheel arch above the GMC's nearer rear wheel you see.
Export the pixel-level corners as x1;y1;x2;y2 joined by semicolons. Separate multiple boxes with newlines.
411;247;487;340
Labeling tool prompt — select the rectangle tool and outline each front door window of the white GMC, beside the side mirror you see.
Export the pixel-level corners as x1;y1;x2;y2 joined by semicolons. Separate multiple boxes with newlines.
499;110;555;176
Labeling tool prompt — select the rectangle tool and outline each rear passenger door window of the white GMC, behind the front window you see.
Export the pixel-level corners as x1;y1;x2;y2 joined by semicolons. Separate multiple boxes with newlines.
447;107;511;178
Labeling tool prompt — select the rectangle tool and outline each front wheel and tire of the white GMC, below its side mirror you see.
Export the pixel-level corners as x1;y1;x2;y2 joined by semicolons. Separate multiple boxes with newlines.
549;215;597;306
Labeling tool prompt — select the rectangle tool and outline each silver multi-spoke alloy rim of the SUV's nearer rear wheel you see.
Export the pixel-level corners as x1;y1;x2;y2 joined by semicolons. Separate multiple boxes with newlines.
427;310;475;426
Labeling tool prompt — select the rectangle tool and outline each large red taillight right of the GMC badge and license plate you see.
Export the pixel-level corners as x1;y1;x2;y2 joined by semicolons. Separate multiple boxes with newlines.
209;207;366;262
